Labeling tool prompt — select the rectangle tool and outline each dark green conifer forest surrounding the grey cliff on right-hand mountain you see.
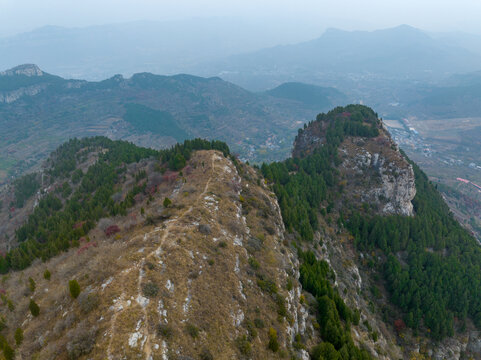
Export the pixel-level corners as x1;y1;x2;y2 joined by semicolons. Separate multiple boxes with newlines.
262;106;481;358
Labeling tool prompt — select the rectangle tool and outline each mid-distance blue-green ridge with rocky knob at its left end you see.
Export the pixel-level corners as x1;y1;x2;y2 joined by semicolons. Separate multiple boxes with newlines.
0;65;347;182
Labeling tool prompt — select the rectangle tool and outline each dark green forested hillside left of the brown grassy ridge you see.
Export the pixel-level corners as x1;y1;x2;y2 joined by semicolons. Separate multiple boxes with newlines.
0;137;229;273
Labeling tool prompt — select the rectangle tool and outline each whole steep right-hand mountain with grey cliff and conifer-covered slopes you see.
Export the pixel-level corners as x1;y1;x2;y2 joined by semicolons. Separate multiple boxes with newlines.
262;105;481;359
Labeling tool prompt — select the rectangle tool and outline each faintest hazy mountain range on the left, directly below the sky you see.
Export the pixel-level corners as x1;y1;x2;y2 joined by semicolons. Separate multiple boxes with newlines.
0;18;316;80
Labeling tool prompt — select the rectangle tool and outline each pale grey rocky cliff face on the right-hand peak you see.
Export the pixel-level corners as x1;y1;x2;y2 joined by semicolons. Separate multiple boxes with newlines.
293;116;416;216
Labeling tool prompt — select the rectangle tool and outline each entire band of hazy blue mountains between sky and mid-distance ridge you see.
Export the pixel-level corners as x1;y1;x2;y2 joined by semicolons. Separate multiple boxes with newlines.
0;18;481;91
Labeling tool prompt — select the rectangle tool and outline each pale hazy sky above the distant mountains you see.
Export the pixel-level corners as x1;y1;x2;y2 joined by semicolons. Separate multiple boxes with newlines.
0;0;481;36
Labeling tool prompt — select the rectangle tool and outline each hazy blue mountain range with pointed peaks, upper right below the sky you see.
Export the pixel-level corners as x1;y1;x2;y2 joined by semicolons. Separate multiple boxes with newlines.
203;25;481;89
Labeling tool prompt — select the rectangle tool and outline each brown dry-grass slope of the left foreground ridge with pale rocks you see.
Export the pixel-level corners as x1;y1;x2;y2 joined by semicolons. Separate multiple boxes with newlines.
0;138;312;359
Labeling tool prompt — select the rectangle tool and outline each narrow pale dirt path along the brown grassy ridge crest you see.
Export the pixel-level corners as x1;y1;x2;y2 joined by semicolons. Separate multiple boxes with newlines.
107;153;217;360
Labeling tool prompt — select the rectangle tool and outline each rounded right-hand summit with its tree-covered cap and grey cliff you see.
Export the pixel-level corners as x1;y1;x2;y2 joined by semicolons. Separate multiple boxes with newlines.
292;105;416;216
